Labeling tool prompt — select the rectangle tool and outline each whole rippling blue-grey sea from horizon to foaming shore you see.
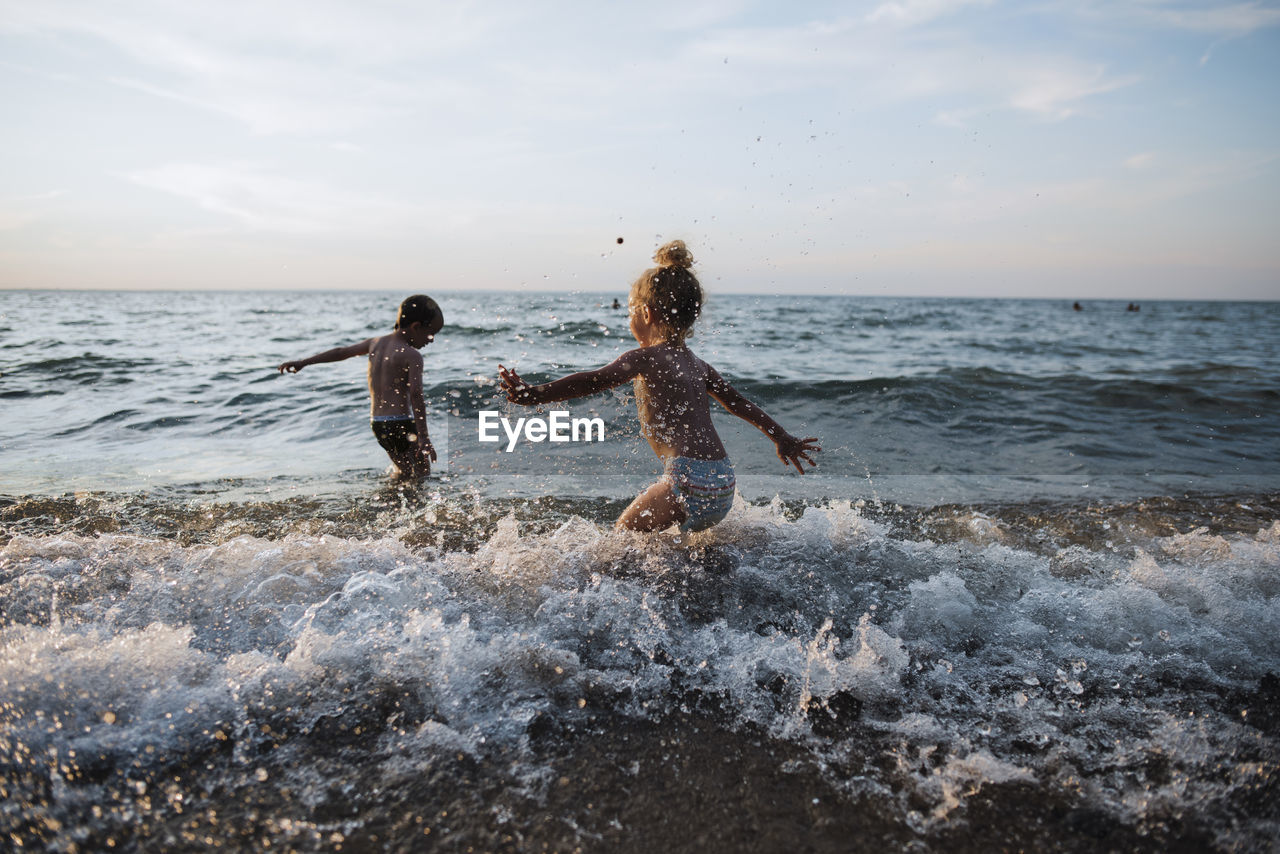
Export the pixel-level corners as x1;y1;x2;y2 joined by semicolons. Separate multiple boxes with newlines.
0;287;1280;851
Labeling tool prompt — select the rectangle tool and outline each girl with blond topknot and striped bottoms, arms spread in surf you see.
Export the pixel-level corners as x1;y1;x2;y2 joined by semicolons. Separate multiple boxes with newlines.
498;241;822;531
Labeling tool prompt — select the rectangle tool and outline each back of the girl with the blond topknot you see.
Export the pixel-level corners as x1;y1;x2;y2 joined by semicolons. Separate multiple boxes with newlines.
632;343;726;460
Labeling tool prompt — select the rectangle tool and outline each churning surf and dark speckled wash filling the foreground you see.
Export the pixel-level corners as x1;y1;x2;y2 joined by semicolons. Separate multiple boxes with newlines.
0;491;1280;850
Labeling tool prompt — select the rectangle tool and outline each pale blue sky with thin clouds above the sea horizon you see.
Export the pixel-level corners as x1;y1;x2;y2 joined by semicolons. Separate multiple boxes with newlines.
0;0;1280;300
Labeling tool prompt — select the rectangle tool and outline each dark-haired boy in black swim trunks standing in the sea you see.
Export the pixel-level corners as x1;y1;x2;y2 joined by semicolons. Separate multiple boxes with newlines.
280;293;444;479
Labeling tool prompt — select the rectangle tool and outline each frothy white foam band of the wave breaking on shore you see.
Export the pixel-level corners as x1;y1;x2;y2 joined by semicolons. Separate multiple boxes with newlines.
0;504;1280;832
